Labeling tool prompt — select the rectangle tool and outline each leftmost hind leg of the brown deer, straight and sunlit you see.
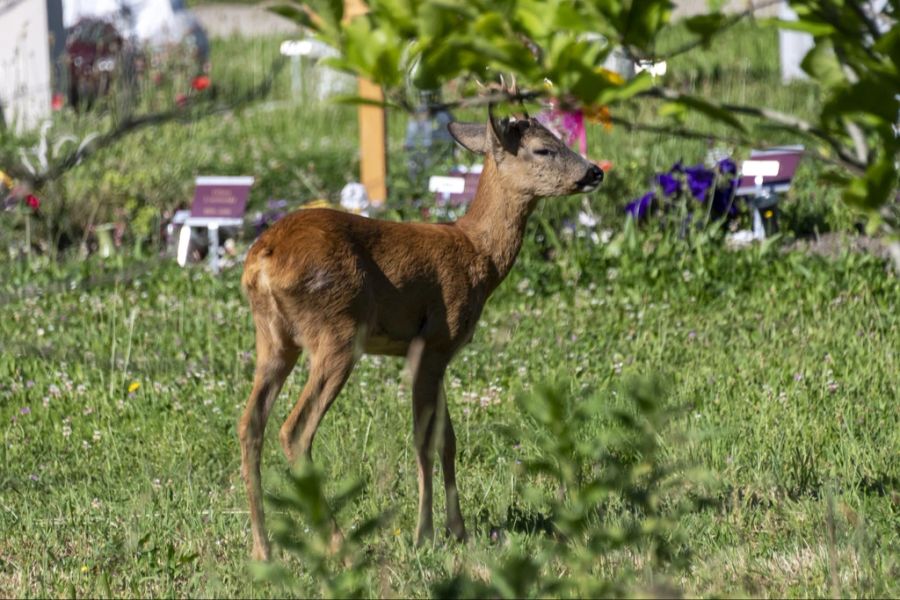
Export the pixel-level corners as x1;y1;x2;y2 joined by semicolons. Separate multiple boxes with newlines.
238;317;300;560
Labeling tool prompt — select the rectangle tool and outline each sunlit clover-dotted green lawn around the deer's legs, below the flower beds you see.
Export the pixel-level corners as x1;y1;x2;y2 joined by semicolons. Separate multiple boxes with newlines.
0;231;900;596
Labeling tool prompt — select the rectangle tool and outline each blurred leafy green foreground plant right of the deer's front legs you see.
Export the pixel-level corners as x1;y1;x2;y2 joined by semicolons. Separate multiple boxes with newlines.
434;379;702;598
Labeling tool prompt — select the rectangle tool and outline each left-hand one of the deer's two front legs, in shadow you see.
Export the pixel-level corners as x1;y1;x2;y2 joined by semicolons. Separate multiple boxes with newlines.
410;351;447;545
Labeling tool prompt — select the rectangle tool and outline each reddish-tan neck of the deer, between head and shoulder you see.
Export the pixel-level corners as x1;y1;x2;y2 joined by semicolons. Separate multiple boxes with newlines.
457;155;535;289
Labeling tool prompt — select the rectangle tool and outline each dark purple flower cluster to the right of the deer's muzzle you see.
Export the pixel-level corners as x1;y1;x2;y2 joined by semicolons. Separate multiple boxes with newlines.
625;158;737;220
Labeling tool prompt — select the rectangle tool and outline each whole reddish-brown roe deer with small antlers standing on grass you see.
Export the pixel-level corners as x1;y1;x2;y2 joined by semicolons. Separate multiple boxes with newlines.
239;108;603;559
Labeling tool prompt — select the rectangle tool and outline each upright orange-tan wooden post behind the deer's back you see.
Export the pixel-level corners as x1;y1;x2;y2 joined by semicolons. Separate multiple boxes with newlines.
344;0;387;206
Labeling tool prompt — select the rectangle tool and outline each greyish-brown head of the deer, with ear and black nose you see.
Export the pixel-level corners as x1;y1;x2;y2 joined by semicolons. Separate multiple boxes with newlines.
448;110;603;198
